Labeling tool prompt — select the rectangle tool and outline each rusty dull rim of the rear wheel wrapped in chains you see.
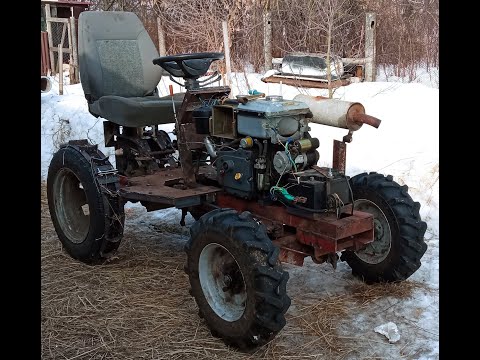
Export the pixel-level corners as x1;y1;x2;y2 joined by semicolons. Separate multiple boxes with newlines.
53;168;90;244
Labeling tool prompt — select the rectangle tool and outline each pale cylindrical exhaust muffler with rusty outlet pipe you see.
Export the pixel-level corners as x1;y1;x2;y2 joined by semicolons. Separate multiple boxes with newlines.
293;94;381;131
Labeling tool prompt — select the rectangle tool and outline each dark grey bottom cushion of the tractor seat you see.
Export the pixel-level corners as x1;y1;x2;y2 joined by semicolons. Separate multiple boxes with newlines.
89;93;185;127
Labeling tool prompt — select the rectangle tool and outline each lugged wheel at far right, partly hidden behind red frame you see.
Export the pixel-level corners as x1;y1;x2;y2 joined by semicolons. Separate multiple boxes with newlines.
341;172;427;282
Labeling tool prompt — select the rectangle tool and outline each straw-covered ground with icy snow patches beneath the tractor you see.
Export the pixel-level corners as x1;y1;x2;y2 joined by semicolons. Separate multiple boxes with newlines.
41;184;438;360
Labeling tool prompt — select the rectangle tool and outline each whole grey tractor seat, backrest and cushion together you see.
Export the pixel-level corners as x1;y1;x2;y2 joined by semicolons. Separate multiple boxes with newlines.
78;11;185;127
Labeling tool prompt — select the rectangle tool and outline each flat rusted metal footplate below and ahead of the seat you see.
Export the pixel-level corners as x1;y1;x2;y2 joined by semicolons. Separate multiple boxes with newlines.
120;168;221;208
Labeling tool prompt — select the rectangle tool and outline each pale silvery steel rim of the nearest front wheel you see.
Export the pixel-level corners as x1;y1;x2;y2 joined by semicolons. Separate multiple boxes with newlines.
198;243;247;322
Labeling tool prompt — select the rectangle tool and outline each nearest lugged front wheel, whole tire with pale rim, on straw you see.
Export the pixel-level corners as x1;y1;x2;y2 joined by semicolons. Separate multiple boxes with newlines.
185;209;290;350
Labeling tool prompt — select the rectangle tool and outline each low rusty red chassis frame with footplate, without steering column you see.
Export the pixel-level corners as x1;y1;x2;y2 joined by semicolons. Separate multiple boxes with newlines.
119;148;374;267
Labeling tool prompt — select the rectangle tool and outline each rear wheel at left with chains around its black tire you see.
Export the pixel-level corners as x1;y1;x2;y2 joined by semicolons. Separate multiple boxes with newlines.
47;145;125;264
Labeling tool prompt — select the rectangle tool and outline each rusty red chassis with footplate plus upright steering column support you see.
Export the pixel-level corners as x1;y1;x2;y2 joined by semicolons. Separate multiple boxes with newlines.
111;83;374;267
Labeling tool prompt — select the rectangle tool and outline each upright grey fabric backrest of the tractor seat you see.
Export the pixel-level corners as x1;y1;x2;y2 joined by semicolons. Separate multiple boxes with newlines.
78;11;162;102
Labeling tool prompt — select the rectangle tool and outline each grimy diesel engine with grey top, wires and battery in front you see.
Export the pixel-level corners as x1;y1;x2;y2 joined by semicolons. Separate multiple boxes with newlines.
192;96;352;212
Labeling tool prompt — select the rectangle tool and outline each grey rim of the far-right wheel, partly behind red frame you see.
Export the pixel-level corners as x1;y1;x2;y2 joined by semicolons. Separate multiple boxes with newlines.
355;199;392;265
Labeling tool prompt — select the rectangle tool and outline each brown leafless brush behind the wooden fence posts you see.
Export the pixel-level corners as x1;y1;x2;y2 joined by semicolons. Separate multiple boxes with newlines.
87;0;439;79
